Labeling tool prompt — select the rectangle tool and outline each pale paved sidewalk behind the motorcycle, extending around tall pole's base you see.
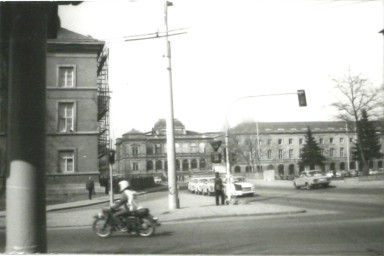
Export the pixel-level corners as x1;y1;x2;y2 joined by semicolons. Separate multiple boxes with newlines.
0;185;305;229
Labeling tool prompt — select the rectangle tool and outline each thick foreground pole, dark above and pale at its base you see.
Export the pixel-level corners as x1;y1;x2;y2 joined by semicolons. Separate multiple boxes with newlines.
6;2;48;254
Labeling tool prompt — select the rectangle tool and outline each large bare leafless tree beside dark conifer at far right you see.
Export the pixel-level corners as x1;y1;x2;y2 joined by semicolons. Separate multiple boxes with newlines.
331;70;382;173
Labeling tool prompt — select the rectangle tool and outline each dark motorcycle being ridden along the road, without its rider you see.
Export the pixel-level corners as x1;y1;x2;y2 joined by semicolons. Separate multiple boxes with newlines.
92;207;161;238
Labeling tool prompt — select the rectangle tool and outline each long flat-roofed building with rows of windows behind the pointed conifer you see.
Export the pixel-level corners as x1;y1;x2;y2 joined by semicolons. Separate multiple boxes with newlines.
230;122;384;176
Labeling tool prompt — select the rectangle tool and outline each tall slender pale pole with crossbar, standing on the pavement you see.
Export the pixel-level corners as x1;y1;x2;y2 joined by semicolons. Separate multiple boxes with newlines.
164;0;179;210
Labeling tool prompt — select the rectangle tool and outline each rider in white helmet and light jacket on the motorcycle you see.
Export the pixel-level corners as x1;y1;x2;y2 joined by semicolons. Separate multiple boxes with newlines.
111;180;137;232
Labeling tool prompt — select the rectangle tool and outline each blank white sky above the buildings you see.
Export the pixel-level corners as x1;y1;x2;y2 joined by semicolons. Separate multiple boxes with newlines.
59;0;384;138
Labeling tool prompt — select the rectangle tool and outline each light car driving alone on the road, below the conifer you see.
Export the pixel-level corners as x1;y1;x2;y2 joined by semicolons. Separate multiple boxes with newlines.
293;170;331;189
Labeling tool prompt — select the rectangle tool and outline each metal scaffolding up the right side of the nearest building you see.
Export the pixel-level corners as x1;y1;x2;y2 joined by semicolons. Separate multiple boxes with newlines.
97;45;111;178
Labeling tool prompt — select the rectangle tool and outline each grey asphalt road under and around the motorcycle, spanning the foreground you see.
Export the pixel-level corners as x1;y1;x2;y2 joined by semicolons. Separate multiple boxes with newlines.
0;185;384;255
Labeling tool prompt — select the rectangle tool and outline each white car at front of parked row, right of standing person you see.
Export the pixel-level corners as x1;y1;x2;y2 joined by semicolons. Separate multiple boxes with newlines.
223;176;255;196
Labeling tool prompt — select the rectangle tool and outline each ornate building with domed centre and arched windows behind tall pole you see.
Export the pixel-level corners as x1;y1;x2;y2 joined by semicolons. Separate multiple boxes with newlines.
116;119;221;176
